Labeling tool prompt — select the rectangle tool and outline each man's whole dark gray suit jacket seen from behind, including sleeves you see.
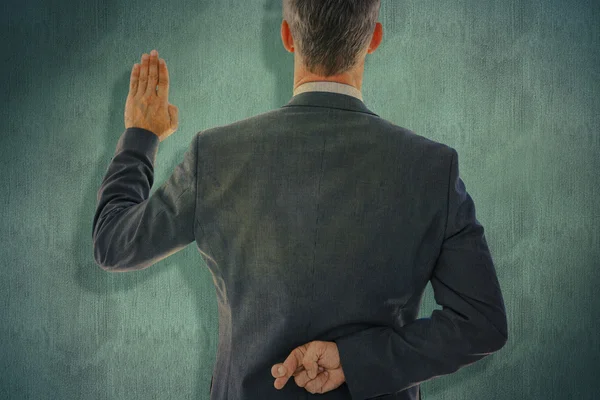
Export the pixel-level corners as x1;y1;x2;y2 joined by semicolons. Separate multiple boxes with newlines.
93;92;507;400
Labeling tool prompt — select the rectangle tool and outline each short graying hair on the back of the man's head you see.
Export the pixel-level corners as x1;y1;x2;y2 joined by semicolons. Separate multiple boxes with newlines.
283;0;381;77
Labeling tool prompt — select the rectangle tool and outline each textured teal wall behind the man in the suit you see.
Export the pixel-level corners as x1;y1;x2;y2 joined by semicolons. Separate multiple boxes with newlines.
0;0;600;400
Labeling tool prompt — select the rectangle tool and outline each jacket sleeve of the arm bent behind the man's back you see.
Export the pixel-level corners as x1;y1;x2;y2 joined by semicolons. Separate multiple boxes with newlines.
334;148;508;400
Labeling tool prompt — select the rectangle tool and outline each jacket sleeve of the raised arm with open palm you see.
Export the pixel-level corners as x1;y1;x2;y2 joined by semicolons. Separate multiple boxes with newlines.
92;128;199;272
